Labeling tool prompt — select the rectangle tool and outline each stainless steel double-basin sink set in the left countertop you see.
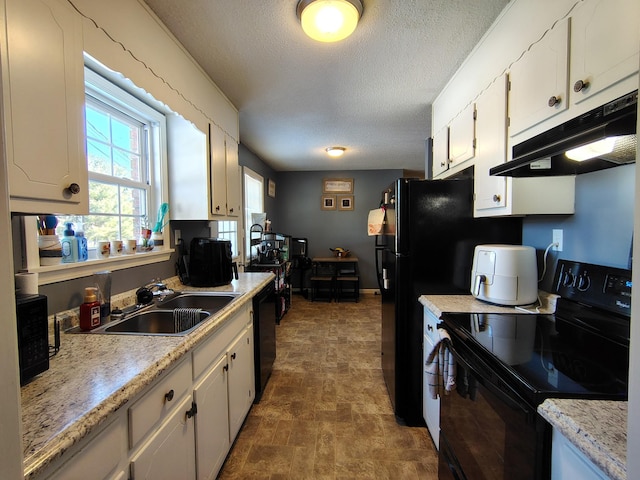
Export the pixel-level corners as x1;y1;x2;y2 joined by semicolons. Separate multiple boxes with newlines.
70;292;241;336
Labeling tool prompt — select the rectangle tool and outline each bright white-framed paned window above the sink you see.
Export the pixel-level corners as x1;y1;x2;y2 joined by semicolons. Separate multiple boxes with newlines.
56;68;165;250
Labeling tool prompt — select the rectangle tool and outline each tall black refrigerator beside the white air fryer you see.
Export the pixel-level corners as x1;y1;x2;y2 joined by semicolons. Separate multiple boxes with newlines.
375;178;522;426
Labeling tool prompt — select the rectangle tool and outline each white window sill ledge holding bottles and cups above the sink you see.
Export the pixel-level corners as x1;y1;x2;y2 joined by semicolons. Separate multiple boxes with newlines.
28;248;175;285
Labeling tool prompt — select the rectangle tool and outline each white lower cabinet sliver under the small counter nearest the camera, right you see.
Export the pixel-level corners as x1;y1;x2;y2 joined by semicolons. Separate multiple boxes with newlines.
551;428;609;480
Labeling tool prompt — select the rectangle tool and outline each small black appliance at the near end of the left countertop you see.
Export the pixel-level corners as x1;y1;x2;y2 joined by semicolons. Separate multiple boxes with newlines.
16;294;49;385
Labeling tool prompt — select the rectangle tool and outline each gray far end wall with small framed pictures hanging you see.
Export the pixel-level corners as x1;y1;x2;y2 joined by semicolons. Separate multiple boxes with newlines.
272;170;403;289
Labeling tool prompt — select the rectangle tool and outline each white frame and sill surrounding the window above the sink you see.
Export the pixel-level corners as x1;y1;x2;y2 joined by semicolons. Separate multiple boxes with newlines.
22;61;174;285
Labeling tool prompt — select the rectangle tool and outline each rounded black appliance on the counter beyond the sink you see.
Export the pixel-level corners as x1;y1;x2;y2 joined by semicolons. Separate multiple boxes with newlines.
189;237;238;287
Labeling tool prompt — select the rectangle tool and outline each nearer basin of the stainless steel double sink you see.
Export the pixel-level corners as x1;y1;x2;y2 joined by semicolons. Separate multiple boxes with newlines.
101;310;211;335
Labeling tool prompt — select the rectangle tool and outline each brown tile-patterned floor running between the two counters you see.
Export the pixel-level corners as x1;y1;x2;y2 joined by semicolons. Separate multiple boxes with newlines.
218;294;437;480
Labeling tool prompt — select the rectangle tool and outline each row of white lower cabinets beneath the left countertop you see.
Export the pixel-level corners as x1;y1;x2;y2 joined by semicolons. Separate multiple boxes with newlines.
38;300;255;480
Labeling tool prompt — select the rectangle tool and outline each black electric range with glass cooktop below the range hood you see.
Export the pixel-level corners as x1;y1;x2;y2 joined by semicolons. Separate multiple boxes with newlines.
439;260;631;480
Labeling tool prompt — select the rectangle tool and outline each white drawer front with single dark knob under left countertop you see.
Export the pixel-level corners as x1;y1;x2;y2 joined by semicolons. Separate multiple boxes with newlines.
129;357;191;448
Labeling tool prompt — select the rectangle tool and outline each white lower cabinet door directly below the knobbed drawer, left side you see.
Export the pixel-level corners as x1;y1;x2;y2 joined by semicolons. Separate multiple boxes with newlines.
131;395;196;480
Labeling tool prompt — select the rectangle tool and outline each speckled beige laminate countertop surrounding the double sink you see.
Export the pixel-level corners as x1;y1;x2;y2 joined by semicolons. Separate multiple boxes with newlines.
21;273;273;479
